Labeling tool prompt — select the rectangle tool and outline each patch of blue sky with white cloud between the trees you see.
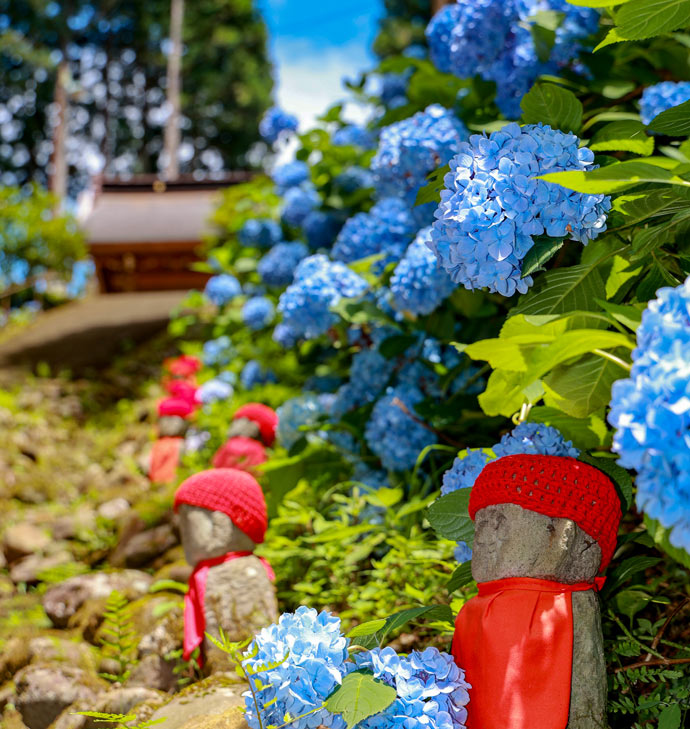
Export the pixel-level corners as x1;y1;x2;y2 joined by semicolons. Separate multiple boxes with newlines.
257;0;382;134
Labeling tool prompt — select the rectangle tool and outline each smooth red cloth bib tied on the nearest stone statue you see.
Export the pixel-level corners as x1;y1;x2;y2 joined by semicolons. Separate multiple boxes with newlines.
452;577;597;729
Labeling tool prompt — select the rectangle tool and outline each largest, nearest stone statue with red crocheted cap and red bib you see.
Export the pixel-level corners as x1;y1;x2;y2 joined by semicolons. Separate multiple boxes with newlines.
453;454;621;729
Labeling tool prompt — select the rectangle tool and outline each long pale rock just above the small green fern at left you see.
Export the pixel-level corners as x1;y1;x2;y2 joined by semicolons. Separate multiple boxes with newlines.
43;570;151;628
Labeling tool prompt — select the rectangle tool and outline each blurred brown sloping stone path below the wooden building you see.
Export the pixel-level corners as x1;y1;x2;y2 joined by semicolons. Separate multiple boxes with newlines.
0;291;186;372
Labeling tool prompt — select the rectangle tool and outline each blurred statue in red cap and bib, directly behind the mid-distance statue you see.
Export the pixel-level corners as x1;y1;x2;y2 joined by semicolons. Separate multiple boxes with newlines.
212;403;278;473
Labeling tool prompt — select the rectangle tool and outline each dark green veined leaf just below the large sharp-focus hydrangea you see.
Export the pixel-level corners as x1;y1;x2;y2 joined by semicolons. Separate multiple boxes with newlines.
511;265;606;314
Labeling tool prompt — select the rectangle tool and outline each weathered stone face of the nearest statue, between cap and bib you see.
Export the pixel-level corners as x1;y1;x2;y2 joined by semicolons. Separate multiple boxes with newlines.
472;504;601;584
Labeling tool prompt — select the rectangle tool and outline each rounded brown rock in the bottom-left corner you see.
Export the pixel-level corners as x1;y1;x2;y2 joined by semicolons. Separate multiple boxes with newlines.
14;664;107;729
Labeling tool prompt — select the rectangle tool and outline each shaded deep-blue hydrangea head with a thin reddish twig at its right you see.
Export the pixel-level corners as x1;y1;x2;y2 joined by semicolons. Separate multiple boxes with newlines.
364;385;436;471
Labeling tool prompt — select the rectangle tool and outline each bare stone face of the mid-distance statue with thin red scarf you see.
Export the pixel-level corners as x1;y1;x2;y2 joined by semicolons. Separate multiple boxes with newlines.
178;504;256;565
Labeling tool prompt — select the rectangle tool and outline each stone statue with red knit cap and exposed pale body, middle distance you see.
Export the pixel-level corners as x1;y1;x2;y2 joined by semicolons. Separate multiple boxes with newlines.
174;468;278;672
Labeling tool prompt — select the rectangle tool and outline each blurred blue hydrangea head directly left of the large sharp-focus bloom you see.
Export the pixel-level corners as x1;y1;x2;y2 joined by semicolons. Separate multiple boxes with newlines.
333;197;417;270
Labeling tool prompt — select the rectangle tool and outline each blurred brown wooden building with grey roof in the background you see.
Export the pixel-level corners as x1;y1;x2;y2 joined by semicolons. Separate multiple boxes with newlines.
84;172;250;293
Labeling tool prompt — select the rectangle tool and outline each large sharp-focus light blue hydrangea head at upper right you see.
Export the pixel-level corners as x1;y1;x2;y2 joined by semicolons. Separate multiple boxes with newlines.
429;124;611;296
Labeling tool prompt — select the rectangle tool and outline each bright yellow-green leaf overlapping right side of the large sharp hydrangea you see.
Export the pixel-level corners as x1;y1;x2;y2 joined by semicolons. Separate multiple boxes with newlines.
537;160;690;195
